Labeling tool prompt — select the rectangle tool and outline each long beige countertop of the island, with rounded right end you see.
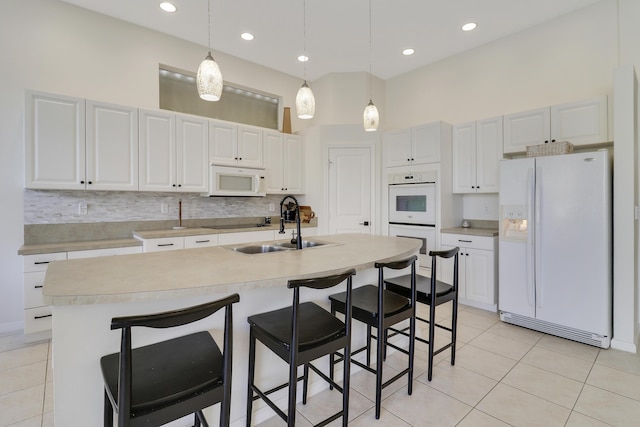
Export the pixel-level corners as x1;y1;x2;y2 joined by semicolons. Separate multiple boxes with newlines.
43;234;420;306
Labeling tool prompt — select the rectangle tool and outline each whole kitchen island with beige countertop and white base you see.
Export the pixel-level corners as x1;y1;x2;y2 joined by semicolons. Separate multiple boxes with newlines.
44;234;420;426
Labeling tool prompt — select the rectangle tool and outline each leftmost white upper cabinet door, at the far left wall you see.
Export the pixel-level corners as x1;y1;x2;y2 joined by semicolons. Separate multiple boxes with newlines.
25;92;86;190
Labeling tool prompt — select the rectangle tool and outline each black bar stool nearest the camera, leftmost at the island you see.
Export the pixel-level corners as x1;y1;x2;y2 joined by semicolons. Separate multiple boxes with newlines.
100;294;240;427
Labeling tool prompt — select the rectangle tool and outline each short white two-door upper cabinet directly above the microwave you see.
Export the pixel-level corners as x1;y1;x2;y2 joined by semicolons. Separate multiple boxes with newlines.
209;120;264;168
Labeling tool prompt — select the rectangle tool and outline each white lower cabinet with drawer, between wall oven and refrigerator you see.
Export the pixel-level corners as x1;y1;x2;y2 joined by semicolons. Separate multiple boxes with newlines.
439;233;498;312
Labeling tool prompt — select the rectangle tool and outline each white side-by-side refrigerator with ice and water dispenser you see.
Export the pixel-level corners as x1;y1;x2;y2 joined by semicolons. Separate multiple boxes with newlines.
498;150;612;348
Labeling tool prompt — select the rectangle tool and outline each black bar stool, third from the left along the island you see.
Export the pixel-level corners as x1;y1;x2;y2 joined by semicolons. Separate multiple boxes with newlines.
329;255;417;419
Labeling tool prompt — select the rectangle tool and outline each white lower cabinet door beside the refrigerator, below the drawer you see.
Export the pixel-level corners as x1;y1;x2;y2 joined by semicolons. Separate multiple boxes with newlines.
463;248;496;305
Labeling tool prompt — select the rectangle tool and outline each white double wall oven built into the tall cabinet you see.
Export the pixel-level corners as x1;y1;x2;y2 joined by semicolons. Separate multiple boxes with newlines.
389;171;437;269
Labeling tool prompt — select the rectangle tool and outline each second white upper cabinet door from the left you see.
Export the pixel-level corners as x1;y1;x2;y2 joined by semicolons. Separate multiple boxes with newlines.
86;101;138;191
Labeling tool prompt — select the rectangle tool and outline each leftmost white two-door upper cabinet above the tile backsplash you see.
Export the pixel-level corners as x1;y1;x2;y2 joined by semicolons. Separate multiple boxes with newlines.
25;92;138;191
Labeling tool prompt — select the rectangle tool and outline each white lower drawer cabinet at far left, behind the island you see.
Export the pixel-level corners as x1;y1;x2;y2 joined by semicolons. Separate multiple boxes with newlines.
23;246;142;339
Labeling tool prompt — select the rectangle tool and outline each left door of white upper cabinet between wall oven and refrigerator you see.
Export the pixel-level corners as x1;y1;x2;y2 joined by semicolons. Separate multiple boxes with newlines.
452;122;476;193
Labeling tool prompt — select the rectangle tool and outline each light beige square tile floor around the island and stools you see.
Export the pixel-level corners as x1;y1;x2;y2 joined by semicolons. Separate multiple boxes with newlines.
0;306;640;427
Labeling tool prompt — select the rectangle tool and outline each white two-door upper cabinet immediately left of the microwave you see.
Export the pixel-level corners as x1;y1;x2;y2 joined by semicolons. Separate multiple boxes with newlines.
140;111;209;193
